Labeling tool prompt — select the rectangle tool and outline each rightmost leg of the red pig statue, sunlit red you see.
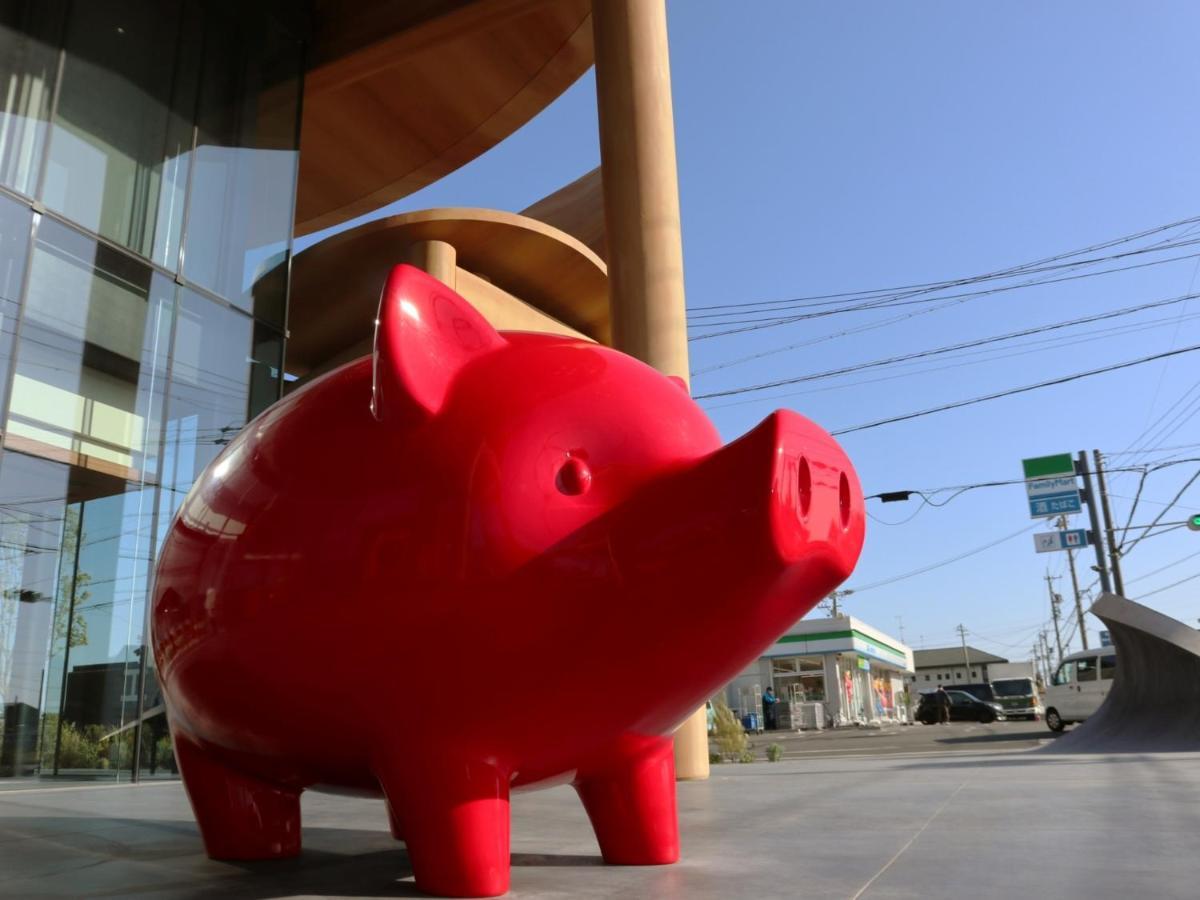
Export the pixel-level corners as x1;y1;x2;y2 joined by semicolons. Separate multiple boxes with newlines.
575;738;679;865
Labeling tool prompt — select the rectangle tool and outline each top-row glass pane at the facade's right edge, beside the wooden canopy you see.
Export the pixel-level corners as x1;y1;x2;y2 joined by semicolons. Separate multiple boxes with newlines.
184;19;300;328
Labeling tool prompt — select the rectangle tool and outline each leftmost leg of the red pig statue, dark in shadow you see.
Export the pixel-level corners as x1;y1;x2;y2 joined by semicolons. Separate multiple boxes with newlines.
174;732;300;859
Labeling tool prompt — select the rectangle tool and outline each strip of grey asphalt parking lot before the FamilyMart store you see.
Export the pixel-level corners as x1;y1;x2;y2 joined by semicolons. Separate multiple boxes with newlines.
729;721;1058;760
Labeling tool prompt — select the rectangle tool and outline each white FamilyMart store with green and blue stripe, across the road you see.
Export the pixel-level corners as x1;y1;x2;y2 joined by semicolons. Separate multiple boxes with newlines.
726;616;913;727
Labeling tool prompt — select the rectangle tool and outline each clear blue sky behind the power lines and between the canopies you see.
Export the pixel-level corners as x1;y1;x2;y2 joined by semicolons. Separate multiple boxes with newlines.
300;0;1200;659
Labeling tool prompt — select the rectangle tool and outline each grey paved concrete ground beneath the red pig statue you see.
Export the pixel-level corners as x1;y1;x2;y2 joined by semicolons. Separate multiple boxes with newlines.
0;744;1200;900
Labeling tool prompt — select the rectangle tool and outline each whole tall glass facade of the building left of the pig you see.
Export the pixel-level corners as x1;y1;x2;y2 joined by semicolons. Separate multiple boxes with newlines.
0;0;304;780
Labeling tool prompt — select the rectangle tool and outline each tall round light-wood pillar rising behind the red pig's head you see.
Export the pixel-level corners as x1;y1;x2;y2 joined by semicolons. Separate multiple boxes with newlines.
592;0;708;779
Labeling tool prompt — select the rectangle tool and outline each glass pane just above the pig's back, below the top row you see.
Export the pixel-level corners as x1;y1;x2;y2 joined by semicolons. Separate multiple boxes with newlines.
160;290;253;528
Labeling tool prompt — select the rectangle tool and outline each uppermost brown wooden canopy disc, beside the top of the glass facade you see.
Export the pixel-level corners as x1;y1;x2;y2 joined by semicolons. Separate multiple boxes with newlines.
295;0;593;235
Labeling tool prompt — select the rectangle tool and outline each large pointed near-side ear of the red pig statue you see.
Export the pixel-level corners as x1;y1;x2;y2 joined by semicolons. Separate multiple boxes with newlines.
371;265;504;419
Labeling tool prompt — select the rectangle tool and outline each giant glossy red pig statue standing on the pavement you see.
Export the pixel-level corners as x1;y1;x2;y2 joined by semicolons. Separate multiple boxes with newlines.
152;266;863;896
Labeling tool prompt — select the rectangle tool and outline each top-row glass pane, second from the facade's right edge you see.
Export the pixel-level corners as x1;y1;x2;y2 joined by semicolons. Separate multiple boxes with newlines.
43;0;199;270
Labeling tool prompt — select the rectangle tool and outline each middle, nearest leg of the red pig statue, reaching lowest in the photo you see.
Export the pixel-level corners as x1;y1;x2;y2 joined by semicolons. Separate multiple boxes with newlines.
376;757;509;896
